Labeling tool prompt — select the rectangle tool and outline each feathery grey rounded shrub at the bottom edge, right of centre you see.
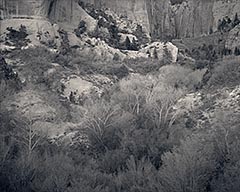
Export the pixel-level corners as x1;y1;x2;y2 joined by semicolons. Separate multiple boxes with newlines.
159;136;216;192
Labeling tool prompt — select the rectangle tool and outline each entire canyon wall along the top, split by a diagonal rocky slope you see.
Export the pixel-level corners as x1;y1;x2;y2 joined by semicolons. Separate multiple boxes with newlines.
0;0;240;40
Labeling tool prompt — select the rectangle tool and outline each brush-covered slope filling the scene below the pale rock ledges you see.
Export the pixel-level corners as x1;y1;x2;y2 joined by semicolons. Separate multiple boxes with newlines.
0;2;240;192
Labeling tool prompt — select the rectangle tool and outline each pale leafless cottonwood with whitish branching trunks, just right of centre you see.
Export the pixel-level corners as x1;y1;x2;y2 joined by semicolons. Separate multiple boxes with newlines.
119;73;184;135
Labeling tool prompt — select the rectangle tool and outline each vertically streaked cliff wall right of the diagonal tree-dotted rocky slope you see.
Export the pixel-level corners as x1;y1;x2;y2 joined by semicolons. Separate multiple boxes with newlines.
82;0;240;39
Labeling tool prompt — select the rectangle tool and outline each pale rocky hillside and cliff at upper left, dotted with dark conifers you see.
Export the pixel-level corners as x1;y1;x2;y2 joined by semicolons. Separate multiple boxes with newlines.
0;0;177;62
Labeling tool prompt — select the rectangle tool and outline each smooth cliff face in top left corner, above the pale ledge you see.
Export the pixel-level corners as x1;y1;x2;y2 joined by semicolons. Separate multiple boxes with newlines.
0;0;96;30
